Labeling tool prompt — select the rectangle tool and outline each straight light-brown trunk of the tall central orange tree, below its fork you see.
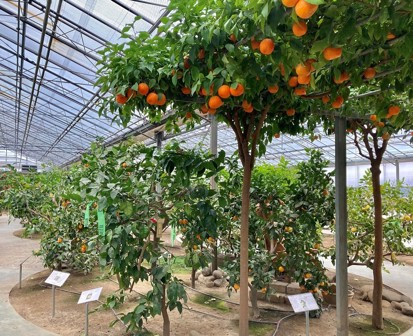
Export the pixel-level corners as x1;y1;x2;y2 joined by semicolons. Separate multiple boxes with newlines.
239;156;252;336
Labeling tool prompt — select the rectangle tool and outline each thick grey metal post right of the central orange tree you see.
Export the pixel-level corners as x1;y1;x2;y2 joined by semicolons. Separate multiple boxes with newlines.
335;117;348;336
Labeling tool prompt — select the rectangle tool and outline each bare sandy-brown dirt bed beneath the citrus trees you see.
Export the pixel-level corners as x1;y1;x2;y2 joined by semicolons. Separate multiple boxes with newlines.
10;231;413;336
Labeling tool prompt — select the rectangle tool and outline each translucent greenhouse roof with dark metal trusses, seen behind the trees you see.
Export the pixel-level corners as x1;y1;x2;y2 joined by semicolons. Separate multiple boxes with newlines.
0;0;413;165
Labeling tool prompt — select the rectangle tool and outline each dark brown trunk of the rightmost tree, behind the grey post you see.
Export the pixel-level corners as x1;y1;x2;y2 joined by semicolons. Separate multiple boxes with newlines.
370;164;384;329
